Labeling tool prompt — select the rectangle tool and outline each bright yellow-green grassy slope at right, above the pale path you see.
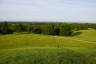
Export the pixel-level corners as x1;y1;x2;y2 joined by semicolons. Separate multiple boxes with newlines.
72;29;96;42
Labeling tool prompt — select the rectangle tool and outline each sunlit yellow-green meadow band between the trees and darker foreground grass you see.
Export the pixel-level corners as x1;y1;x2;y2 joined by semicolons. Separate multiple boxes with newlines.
0;30;96;49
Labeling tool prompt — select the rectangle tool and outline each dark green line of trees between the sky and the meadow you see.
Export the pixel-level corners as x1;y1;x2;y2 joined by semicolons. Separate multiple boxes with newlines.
0;22;96;36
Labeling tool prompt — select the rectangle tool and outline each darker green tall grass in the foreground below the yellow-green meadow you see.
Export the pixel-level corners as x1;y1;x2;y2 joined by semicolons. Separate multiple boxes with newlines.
0;48;96;64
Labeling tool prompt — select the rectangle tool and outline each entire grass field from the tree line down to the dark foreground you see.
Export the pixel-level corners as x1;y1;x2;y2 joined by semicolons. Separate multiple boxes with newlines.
0;29;96;64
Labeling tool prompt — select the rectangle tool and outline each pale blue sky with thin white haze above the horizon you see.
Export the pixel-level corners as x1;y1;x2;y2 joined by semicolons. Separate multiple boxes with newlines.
0;0;96;23
